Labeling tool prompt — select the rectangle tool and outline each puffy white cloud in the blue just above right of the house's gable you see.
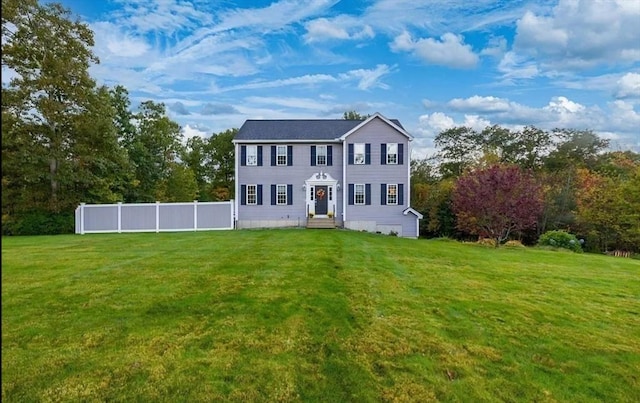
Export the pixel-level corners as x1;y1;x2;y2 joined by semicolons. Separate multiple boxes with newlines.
389;31;479;68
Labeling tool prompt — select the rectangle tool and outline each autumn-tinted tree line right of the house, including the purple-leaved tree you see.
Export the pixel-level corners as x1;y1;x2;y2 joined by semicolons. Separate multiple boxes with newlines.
411;126;640;252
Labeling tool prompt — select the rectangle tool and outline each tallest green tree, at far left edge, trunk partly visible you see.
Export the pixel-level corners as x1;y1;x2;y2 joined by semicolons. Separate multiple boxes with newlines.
2;0;98;211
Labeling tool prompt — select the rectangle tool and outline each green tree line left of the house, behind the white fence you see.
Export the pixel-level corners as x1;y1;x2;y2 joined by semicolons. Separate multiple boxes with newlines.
2;0;236;235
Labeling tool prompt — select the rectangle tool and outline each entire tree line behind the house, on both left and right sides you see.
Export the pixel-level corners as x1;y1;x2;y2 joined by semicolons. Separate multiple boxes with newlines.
2;0;640;252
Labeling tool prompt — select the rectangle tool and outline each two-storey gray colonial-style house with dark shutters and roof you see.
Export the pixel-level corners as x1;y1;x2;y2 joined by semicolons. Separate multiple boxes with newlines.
233;113;422;238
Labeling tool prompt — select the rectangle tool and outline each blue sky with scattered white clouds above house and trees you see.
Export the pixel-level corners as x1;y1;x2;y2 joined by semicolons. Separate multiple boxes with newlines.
48;0;640;158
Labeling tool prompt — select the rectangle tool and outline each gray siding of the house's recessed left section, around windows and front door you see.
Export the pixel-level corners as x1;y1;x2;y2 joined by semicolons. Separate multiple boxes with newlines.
237;142;344;228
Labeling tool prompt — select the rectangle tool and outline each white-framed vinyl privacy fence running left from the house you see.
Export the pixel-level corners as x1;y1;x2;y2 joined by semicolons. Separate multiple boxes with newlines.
75;200;234;234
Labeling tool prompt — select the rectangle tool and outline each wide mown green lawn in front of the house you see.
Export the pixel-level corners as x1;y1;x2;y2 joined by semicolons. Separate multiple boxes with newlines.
2;230;640;402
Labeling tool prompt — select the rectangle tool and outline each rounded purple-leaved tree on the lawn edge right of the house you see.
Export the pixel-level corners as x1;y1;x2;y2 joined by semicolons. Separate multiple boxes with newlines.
452;165;543;248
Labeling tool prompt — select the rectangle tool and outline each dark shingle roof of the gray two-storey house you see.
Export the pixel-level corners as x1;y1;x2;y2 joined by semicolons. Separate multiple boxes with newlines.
234;119;402;141
